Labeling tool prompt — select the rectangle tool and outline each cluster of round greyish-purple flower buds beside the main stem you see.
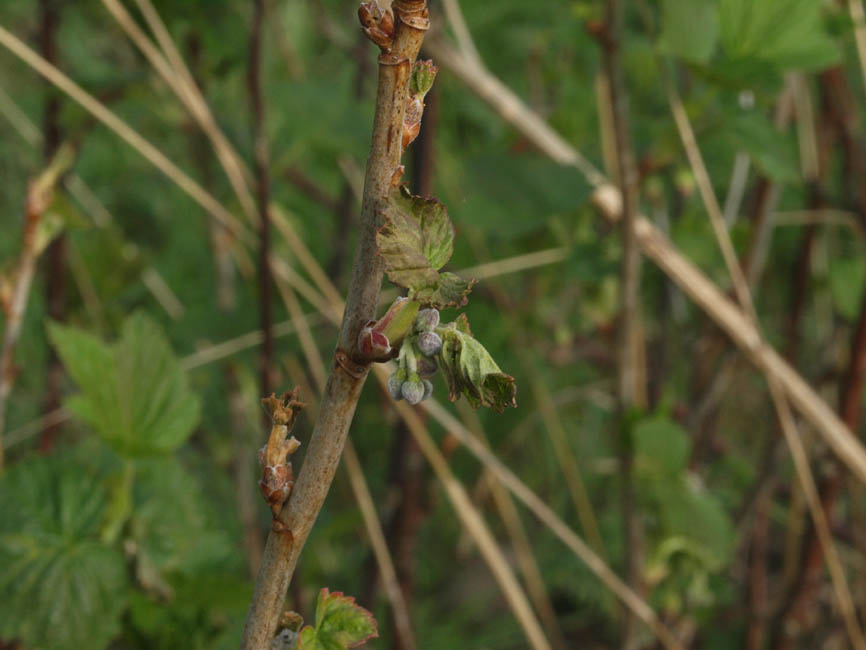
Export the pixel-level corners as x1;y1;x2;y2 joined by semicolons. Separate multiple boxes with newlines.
388;309;442;404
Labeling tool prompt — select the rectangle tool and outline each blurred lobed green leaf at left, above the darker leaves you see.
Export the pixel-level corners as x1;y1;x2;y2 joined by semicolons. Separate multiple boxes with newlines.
48;313;200;456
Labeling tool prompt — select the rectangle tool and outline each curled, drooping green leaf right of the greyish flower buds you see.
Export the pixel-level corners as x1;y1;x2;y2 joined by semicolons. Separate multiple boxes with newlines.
436;318;517;413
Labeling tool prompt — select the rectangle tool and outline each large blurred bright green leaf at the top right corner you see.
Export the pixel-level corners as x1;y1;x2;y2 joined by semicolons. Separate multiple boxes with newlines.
719;0;841;70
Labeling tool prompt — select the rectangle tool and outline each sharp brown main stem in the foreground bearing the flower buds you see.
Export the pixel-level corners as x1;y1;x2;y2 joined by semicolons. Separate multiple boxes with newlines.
241;0;428;650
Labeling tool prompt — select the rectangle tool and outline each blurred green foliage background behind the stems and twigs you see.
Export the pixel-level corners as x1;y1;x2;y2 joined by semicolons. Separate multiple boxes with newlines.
0;0;866;650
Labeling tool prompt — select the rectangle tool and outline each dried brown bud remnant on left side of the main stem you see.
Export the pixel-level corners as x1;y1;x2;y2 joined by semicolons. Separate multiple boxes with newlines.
259;388;304;518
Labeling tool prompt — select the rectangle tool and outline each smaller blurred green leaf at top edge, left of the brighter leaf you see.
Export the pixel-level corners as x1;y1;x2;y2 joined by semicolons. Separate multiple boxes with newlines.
659;0;719;63
